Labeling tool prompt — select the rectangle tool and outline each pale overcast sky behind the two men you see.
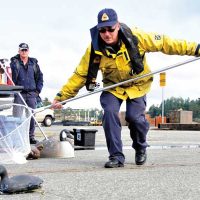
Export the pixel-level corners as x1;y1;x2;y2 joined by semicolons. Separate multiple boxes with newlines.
0;0;200;110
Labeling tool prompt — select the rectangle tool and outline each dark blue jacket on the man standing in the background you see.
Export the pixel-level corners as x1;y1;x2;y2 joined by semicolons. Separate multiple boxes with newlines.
10;54;43;94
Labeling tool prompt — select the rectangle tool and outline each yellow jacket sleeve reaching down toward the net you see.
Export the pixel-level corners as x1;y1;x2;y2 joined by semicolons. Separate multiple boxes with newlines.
55;46;91;101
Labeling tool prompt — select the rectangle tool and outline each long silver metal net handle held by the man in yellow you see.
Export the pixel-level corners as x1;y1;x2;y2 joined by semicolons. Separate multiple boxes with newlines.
34;57;200;113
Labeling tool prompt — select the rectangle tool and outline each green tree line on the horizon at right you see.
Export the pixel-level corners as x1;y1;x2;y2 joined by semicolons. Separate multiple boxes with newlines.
147;97;200;121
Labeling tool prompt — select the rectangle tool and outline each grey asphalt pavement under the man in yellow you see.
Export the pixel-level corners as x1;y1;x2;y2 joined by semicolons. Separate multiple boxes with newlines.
0;125;200;200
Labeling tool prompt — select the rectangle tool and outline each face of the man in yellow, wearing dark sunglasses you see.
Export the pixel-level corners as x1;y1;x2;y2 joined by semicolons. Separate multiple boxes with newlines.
98;23;120;45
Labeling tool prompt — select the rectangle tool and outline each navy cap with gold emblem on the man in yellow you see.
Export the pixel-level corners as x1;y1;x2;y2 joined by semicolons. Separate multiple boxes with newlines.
97;8;118;29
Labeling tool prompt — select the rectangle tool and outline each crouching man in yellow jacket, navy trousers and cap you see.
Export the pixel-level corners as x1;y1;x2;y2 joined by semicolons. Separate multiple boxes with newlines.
53;9;200;168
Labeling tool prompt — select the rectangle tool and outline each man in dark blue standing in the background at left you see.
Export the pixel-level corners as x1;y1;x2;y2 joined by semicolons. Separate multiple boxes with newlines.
10;43;43;144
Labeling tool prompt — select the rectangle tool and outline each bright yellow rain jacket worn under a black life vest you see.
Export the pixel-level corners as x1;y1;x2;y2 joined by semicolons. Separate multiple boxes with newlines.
55;28;200;101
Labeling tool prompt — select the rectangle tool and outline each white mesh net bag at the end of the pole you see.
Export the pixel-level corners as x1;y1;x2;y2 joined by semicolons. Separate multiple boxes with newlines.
0;103;31;164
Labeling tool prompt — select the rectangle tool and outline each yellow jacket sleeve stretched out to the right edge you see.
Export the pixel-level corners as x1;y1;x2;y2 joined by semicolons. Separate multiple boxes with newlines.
133;29;200;56
